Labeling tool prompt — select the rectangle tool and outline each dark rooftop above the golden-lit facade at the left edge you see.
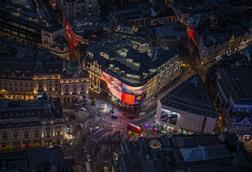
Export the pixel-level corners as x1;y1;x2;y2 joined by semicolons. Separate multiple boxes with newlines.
0;39;64;79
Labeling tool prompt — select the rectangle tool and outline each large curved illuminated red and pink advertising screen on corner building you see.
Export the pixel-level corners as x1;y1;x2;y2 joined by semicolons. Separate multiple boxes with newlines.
101;72;145;105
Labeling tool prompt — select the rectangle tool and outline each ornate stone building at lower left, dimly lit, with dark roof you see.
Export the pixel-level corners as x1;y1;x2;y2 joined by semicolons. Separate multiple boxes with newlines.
0;94;65;151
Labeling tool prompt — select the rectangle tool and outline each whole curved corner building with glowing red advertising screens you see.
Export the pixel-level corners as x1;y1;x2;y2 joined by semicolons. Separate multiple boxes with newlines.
87;41;181;109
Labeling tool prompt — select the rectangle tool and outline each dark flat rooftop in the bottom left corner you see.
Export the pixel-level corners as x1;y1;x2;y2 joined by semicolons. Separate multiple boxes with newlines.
0;147;74;172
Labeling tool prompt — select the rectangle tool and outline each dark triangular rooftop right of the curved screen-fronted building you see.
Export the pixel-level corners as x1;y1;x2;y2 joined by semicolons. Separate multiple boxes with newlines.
160;75;217;118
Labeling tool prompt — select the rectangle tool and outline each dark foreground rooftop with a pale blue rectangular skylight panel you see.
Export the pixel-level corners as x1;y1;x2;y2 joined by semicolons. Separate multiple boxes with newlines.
116;134;252;172
